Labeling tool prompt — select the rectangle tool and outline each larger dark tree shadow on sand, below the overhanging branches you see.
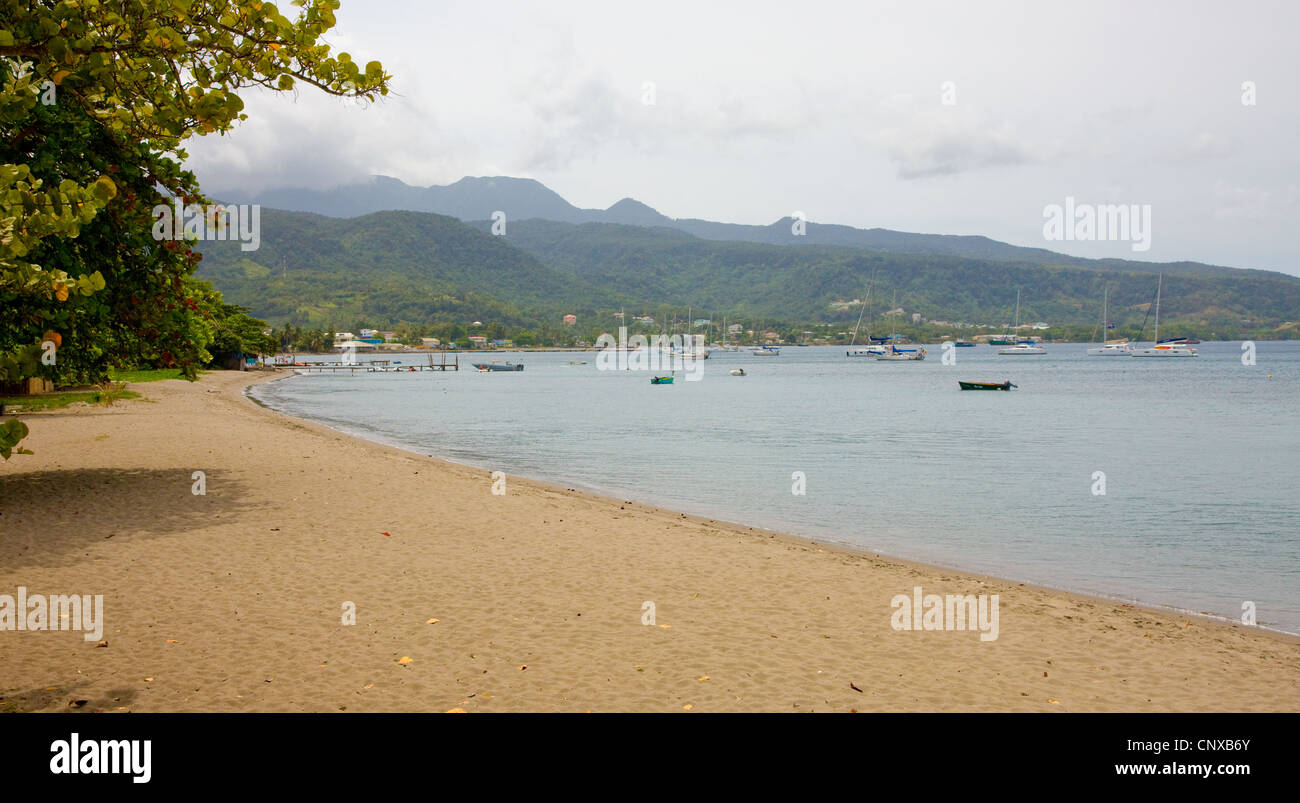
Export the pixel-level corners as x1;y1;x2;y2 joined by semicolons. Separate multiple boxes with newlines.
0;468;250;569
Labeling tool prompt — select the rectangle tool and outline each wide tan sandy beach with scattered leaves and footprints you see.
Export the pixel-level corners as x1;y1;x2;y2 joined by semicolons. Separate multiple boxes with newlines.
0;372;1300;712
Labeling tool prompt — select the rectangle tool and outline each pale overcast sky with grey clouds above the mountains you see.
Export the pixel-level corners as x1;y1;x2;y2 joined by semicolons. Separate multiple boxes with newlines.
187;0;1300;274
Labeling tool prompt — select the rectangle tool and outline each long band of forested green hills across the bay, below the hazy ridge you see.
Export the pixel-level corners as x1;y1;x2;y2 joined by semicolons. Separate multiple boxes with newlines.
199;209;1300;338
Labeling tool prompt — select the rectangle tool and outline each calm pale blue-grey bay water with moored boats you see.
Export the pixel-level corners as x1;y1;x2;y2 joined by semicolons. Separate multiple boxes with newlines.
252;343;1300;633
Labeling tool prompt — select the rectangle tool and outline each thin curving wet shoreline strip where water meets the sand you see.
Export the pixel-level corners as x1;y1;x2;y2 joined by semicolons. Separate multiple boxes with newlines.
241;370;1300;643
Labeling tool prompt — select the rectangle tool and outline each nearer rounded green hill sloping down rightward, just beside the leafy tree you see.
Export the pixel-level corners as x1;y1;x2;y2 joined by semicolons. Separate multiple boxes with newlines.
199;209;625;327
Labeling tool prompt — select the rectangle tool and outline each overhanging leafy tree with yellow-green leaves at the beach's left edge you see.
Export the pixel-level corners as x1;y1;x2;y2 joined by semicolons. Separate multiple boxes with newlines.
0;0;389;459
